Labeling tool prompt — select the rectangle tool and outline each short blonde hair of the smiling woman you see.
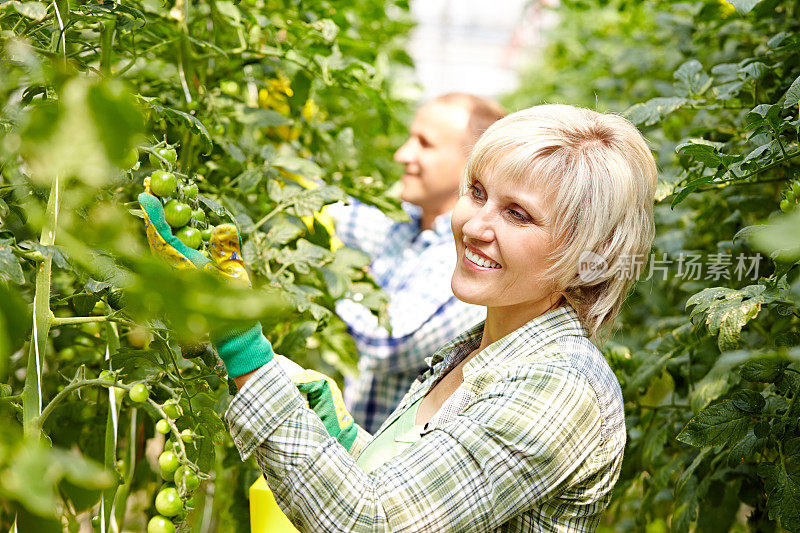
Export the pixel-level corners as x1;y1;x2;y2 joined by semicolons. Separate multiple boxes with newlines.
461;105;657;338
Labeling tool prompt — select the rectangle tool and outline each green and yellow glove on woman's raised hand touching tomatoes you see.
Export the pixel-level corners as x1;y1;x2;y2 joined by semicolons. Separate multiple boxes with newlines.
139;189;275;378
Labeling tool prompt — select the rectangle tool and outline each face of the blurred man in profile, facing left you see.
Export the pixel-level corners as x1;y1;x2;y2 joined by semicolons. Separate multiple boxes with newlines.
394;102;471;215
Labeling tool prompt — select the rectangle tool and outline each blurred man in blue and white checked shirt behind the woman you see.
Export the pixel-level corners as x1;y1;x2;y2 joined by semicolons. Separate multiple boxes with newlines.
331;93;505;433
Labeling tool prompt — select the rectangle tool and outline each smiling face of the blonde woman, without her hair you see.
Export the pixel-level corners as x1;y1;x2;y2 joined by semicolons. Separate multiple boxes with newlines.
451;168;554;321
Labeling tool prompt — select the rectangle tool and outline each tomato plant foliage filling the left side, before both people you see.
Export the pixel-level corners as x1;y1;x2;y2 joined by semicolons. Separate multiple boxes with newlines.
0;0;412;532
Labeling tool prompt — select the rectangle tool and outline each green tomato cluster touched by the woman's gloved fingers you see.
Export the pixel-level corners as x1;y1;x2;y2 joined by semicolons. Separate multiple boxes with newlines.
149;146;214;250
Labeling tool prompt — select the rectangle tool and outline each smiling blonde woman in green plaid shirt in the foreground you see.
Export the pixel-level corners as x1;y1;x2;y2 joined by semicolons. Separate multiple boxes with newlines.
153;106;656;532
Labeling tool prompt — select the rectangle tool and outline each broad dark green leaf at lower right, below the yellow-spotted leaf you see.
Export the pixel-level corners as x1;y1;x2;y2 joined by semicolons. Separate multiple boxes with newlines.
677;400;751;447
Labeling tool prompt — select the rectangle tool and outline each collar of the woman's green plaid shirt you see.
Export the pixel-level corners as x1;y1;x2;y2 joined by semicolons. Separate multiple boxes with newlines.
427;304;589;367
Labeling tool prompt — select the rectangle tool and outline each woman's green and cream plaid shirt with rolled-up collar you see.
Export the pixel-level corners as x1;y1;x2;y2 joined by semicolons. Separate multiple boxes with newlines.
226;307;625;532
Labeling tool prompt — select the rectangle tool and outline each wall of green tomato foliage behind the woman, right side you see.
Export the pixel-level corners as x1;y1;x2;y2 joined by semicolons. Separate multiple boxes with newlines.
506;0;800;532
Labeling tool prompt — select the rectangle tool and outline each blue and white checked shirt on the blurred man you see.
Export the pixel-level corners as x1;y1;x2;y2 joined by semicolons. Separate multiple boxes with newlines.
329;201;486;432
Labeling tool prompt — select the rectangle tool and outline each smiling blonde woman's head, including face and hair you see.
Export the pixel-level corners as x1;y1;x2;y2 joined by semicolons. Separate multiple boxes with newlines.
452;105;657;337
